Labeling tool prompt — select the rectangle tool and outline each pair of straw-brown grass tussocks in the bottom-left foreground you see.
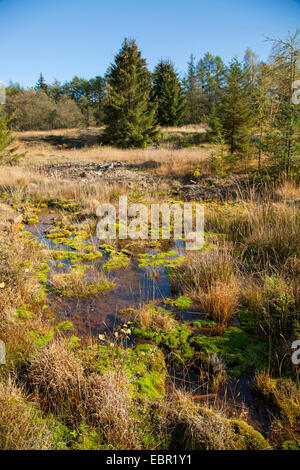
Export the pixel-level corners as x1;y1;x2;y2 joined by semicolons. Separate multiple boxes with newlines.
28;340;136;448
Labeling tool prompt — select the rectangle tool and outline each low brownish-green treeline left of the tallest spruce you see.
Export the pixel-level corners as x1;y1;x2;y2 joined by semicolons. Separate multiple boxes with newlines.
5;73;105;131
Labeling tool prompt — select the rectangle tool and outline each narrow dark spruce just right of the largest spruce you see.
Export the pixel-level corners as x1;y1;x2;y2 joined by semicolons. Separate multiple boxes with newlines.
153;60;185;126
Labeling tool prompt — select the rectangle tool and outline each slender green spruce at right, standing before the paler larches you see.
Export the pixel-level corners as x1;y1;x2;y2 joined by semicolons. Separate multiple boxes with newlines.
219;58;253;156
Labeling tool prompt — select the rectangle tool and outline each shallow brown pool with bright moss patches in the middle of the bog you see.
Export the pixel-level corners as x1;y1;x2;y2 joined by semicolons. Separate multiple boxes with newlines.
25;217;188;337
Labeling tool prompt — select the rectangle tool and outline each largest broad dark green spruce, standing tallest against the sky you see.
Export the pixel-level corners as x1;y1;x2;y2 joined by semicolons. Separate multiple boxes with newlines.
103;39;159;148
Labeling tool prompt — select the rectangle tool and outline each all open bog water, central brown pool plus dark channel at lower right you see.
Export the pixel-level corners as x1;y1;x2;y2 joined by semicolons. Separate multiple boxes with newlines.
25;216;271;435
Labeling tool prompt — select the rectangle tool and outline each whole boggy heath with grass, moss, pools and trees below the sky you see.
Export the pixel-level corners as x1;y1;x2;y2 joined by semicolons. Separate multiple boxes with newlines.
0;31;300;450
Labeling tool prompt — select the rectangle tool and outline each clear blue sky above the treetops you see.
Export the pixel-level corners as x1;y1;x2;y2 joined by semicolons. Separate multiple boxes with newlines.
0;0;300;87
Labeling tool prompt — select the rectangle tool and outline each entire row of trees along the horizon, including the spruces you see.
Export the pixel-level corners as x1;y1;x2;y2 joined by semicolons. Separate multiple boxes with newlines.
1;31;300;173
